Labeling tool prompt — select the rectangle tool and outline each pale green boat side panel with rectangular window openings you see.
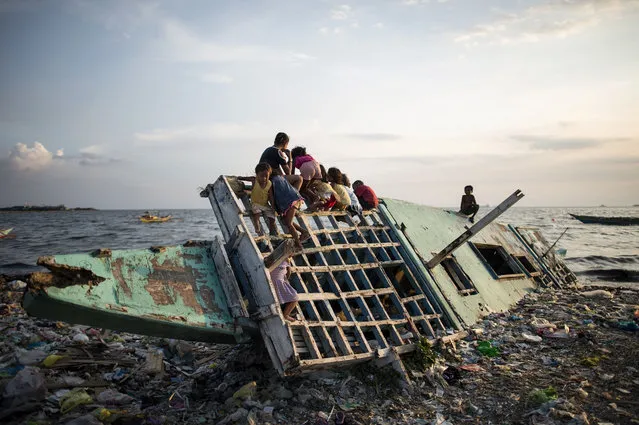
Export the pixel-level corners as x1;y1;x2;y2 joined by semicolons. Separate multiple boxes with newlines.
384;199;536;326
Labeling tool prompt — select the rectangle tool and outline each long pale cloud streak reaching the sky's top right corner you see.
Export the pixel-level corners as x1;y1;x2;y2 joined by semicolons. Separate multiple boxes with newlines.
454;0;639;45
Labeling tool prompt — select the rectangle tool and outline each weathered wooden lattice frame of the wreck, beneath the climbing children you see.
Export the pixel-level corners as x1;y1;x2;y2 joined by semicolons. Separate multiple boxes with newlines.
209;177;447;372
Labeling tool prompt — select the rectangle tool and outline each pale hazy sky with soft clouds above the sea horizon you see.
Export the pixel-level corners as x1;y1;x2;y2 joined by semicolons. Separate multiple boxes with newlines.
0;0;639;209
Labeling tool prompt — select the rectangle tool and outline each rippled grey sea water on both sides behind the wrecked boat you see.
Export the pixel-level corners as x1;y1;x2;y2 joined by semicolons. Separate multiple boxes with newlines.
0;207;639;282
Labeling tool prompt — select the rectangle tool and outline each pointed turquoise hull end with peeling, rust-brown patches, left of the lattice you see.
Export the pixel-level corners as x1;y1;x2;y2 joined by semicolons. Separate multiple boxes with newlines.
25;242;251;342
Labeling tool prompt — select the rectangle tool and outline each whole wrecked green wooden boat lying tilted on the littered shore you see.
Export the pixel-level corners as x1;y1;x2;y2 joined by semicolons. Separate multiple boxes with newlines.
24;176;576;375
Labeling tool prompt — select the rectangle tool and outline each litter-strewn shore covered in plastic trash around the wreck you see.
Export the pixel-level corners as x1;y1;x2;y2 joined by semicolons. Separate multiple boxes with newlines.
0;279;639;425
